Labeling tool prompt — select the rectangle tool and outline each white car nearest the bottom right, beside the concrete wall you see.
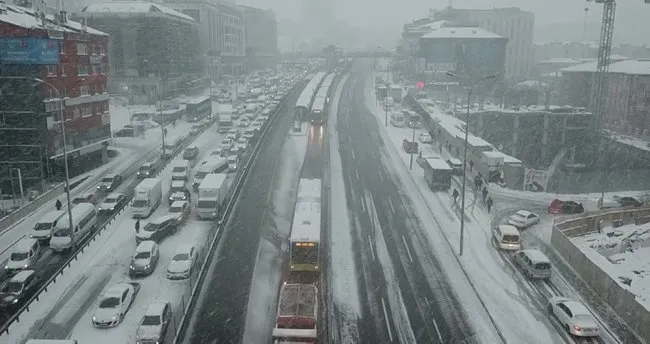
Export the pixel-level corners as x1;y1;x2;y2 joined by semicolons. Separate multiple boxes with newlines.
548;296;599;337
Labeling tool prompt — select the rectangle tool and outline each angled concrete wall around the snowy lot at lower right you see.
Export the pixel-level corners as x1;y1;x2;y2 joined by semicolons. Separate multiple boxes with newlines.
551;208;650;342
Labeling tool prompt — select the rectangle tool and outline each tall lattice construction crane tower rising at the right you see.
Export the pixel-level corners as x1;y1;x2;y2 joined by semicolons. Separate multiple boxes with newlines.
587;0;650;199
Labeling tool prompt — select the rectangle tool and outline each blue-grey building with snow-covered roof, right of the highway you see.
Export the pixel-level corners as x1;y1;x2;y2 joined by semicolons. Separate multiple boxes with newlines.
418;27;508;79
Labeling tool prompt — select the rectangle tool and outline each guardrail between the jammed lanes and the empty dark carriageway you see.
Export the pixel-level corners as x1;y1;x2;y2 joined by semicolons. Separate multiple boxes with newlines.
173;87;296;343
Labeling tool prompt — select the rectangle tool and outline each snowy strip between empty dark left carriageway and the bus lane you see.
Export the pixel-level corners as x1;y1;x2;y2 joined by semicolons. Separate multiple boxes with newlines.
243;123;307;343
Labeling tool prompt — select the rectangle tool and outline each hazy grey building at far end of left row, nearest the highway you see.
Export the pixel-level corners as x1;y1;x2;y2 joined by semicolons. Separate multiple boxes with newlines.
239;6;278;70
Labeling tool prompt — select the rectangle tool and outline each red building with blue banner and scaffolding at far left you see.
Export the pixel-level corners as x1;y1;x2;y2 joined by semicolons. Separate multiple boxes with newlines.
0;5;111;190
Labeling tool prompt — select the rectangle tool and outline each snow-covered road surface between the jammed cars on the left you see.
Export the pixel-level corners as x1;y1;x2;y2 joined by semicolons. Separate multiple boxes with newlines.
0;121;225;343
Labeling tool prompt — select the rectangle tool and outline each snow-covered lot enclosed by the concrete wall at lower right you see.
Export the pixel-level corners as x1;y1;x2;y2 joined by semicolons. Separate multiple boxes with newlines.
571;223;650;309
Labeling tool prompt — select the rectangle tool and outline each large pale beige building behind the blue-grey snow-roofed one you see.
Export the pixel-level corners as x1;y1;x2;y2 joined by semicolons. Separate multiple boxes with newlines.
434;7;535;78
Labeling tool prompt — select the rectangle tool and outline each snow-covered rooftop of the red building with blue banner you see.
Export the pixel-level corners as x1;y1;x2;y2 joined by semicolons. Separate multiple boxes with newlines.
0;5;108;36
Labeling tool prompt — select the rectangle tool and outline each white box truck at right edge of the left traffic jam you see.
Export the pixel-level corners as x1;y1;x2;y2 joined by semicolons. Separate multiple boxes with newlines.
196;173;228;220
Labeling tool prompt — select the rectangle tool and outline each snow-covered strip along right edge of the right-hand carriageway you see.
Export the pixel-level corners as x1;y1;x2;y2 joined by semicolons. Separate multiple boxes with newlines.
366;78;564;343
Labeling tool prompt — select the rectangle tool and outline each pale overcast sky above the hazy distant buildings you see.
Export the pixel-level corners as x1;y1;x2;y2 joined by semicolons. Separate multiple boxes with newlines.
238;0;650;43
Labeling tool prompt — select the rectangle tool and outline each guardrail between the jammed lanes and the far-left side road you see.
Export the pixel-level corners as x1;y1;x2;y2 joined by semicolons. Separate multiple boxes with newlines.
0;121;217;335
